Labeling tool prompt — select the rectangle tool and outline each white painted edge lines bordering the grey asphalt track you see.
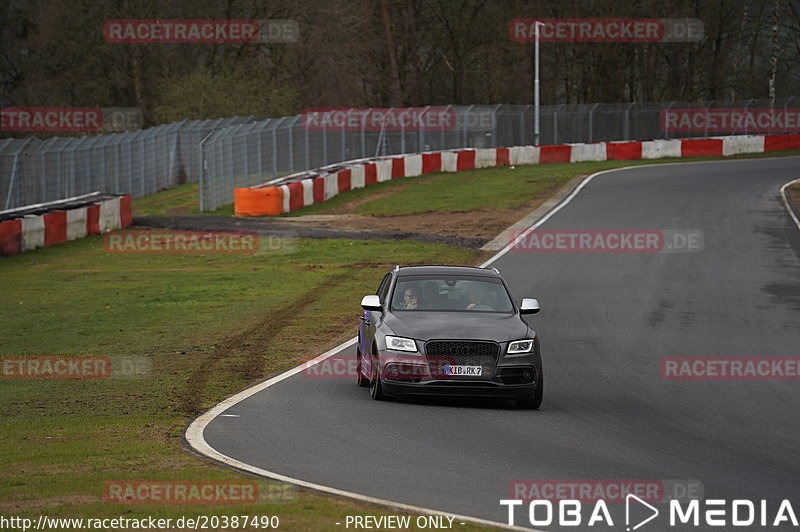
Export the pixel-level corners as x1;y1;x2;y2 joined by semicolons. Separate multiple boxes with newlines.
189;157;800;532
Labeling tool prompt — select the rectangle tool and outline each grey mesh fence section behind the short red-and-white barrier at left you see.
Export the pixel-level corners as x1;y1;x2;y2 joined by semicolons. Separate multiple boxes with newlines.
0;116;255;210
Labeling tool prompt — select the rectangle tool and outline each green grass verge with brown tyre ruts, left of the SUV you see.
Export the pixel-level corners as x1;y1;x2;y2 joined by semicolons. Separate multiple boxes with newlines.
0;237;496;530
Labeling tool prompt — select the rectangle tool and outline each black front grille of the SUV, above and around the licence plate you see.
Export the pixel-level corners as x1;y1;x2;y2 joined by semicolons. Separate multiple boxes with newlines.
425;340;500;380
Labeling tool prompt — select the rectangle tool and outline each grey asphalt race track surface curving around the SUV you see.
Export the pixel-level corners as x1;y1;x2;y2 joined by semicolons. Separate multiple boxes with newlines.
198;157;800;530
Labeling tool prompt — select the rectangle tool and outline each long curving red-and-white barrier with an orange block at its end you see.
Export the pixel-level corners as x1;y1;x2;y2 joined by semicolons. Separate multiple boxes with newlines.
234;135;800;216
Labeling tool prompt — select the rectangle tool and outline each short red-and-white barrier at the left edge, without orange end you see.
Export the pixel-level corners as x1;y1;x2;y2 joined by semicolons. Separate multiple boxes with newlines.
0;196;133;255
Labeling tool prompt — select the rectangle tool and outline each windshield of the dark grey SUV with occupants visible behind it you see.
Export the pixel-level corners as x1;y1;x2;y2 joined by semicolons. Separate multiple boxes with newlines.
391;276;514;313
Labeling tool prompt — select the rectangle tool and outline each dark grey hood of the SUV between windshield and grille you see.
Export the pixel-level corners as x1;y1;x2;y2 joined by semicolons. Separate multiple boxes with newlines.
384;310;528;342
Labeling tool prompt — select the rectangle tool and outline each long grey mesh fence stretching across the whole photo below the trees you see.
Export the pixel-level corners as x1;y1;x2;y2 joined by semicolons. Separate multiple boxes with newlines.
0;97;800;211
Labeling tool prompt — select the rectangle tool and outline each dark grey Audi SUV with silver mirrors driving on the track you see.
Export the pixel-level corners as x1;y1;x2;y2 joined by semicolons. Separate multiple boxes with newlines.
356;266;544;408
